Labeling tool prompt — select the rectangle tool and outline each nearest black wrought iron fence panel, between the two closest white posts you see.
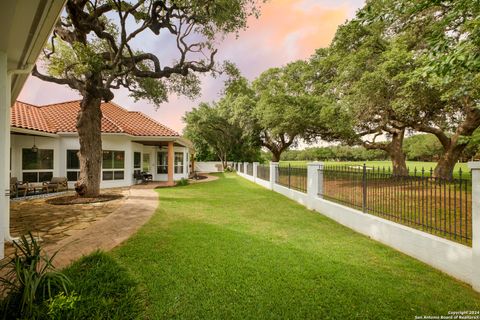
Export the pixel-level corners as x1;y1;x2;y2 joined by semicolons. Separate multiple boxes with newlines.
319;165;472;245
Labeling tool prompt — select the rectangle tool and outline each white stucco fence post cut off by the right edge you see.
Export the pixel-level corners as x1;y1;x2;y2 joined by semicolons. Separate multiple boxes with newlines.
468;161;480;291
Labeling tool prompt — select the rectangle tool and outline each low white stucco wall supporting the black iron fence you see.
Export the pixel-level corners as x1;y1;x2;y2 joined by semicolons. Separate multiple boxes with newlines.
237;164;479;291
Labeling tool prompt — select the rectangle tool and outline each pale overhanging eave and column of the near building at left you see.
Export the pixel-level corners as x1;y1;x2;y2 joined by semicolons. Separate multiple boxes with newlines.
0;0;66;258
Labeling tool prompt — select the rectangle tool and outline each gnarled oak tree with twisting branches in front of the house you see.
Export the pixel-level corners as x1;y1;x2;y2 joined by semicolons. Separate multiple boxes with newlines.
32;0;257;196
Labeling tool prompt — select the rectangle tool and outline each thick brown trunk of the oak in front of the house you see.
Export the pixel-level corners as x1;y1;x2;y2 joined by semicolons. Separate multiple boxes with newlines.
75;93;102;197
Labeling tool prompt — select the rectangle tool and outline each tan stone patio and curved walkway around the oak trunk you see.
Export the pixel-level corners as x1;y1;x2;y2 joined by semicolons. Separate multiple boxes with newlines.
6;174;218;268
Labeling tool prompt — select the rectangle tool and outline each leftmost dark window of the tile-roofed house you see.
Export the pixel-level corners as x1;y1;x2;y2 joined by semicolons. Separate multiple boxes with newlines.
22;149;53;182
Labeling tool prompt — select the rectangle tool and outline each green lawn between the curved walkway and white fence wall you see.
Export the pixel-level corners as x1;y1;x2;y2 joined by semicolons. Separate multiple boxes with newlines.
102;174;480;319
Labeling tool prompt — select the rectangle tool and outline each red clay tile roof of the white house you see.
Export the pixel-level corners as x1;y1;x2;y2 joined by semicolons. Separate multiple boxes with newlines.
11;101;179;137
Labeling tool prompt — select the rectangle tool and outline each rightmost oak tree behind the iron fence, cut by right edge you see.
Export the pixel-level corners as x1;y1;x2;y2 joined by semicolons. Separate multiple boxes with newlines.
361;0;480;179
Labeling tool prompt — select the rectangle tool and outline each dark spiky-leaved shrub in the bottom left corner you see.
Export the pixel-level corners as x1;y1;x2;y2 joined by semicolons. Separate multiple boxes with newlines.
0;233;71;319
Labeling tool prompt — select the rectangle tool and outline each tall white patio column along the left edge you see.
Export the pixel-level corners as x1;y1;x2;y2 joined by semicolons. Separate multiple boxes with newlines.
0;52;11;258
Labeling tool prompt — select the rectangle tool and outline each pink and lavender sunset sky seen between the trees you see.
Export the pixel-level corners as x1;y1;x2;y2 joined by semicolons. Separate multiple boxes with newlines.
18;0;364;132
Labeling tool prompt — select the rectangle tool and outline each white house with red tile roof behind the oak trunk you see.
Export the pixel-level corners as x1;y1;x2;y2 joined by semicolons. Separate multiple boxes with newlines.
10;100;192;188
